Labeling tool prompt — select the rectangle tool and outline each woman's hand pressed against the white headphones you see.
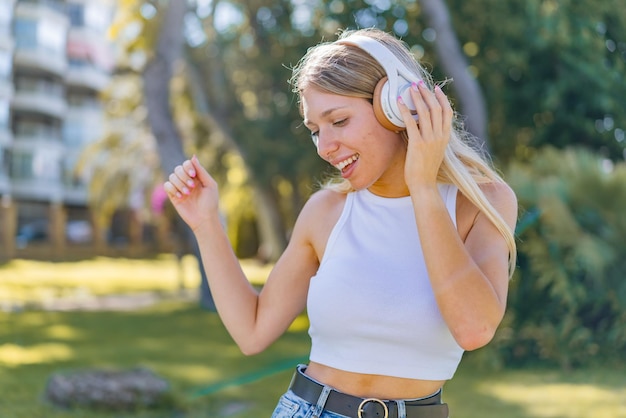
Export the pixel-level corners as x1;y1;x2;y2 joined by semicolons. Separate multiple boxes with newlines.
398;81;454;190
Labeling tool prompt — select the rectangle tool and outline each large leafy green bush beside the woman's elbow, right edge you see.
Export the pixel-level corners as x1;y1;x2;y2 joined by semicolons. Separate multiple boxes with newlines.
500;147;626;367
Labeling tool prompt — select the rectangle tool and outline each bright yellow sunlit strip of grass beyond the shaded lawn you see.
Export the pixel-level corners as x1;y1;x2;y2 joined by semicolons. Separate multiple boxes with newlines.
0;254;270;309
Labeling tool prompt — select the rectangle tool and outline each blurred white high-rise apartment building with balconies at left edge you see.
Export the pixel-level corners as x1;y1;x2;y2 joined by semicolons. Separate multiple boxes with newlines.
0;0;113;259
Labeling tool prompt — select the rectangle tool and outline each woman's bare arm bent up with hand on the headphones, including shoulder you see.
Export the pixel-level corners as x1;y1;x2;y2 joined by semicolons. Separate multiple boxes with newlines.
400;81;517;350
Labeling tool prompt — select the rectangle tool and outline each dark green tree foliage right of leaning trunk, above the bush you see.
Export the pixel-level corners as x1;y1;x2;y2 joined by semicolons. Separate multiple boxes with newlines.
449;0;626;160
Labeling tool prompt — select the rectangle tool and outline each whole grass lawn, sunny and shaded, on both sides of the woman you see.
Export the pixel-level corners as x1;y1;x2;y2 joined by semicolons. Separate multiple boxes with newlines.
0;256;626;418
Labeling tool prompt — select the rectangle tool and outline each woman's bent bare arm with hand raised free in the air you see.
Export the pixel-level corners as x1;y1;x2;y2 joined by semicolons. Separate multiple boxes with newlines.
165;157;318;354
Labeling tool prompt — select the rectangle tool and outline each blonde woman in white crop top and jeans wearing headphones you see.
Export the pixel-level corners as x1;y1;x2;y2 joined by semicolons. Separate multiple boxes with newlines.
165;29;517;418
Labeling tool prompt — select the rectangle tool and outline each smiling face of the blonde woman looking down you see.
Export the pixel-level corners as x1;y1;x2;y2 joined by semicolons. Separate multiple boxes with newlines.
301;87;408;197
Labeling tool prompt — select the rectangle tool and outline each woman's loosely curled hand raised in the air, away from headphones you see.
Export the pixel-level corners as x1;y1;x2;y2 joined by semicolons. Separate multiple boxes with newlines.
163;155;219;232
